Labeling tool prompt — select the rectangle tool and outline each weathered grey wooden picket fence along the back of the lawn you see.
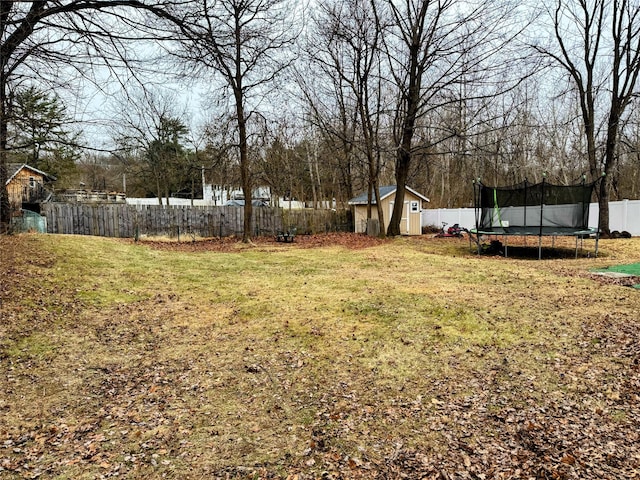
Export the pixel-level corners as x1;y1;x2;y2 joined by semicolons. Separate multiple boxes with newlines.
41;203;353;239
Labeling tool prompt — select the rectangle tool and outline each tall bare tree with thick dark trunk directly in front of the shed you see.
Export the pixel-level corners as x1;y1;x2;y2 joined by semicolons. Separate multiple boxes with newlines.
380;0;517;236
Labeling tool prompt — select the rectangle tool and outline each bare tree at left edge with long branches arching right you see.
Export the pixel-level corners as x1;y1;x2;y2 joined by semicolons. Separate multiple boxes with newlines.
0;0;185;229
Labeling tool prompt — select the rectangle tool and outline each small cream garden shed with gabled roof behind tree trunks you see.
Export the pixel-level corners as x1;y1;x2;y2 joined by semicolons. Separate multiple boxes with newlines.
349;185;429;235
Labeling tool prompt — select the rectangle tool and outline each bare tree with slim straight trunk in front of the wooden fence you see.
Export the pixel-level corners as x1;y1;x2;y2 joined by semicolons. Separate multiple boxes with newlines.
172;0;294;242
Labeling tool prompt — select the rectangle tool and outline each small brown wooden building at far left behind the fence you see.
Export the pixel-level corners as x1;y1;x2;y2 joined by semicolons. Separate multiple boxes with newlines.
7;163;56;212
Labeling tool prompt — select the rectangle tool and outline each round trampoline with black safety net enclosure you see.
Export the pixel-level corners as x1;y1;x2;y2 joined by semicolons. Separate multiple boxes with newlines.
470;179;599;259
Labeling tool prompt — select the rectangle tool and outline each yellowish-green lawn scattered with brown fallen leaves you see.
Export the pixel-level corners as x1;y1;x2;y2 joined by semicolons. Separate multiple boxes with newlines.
0;234;640;480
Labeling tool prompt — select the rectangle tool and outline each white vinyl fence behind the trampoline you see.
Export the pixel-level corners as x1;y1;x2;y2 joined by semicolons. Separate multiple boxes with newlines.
422;200;640;236
